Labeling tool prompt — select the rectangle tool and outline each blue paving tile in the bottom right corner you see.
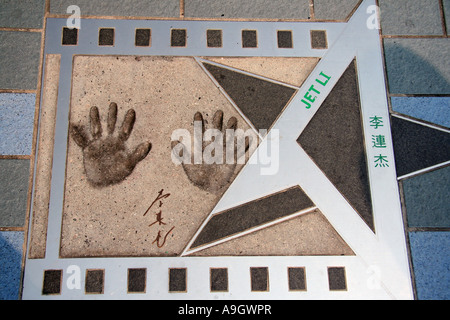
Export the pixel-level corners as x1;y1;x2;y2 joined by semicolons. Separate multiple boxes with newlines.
409;232;450;300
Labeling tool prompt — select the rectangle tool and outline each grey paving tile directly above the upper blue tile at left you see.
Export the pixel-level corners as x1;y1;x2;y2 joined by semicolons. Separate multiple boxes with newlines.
0;31;41;90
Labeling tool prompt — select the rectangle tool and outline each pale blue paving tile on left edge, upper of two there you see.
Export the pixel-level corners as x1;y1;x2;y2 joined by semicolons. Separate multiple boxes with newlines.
0;93;36;155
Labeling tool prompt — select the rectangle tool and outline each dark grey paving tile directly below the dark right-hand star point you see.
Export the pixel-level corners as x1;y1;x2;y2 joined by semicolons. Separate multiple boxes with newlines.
403;167;450;228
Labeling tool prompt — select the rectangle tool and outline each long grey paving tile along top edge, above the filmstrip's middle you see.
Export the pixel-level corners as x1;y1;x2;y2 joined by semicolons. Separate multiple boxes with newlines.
185;0;309;19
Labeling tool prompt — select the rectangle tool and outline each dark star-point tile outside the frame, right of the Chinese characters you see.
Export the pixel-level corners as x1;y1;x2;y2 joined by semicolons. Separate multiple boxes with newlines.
391;117;450;177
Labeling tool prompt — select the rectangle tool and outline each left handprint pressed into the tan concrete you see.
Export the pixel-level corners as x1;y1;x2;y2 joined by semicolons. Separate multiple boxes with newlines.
70;102;152;187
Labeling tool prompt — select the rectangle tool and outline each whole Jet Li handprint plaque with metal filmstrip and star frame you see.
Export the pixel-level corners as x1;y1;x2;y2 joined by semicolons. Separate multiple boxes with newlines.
23;0;412;299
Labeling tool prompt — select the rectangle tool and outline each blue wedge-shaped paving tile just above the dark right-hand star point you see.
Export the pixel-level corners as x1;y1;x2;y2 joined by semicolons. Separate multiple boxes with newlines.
391;97;450;128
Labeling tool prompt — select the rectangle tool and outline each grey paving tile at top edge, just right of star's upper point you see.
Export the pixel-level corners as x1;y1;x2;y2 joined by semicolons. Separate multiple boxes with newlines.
380;0;443;35
